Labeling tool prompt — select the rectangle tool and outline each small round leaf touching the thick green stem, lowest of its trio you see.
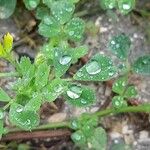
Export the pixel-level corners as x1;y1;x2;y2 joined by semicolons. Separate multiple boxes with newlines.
112;96;127;109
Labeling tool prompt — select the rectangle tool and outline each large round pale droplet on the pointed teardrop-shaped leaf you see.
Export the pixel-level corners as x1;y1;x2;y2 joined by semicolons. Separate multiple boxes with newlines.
86;60;101;75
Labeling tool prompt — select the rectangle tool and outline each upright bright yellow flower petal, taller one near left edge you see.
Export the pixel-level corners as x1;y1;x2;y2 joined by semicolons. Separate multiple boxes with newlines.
3;33;13;53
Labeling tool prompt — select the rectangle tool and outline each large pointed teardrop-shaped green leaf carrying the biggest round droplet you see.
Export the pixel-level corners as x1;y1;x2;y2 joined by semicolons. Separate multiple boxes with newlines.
73;54;117;81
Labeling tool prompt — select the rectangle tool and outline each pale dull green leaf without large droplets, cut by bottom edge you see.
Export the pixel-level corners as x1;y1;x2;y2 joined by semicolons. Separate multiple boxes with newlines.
88;127;107;150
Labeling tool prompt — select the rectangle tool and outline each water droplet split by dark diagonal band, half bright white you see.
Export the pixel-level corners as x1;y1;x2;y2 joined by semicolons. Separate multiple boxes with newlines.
67;85;82;99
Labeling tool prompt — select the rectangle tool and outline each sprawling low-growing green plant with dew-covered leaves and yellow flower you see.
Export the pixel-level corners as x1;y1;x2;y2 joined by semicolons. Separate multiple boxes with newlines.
0;0;150;150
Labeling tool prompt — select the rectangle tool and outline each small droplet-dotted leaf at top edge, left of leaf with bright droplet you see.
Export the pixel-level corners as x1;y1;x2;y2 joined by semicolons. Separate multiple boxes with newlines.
99;0;117;10
